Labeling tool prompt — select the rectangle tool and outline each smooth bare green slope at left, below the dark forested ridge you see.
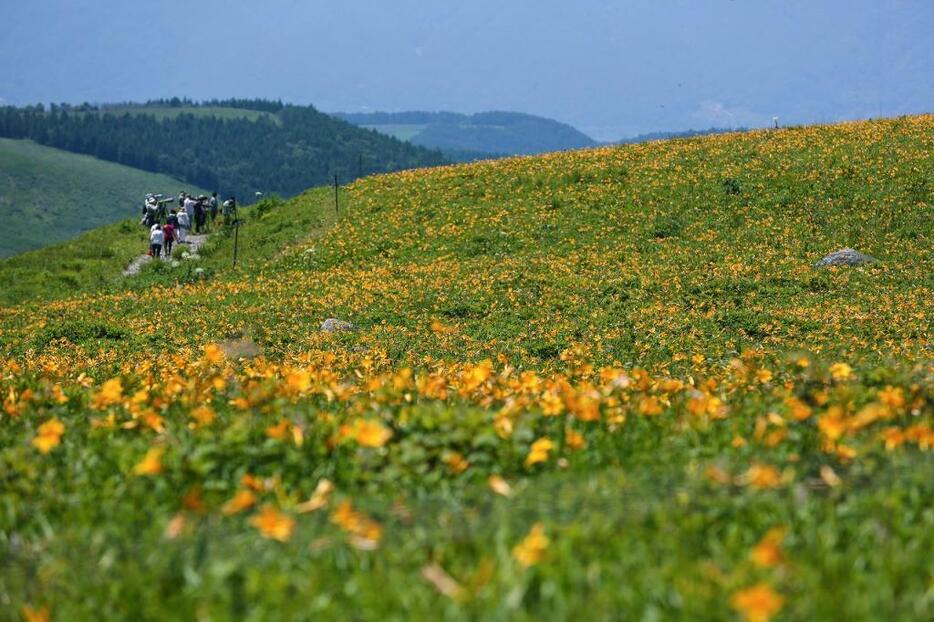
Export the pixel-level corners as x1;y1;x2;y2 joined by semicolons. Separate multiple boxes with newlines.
0;139;203;257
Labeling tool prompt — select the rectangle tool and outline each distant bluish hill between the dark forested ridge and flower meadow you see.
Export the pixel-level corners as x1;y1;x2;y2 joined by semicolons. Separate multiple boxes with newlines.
334;112;598;162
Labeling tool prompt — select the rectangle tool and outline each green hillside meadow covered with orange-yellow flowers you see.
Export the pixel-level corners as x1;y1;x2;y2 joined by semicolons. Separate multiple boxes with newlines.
0;115;934;621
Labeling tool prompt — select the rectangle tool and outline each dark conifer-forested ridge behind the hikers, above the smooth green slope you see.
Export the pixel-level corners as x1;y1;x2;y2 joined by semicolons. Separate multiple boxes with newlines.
0;99;445;199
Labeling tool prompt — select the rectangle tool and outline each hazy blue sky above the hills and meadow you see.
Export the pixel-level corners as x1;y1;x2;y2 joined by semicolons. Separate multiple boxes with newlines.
0;0;934;140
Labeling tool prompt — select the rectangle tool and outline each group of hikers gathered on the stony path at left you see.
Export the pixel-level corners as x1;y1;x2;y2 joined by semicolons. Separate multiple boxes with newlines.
140;192;237;258
